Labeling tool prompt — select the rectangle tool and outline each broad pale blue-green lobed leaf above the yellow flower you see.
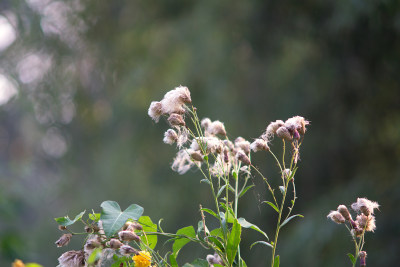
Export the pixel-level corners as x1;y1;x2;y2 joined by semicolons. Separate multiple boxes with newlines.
100;201;143;237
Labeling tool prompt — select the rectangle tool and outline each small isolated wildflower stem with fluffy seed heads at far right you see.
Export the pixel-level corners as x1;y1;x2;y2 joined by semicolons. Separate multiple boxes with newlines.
327;198;379;266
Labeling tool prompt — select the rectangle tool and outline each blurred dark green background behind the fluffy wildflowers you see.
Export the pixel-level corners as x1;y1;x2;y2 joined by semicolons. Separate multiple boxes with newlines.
0;0;400;267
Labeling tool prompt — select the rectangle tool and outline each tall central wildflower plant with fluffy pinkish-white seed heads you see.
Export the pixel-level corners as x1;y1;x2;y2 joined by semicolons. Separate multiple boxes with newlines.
148;86;309;266
